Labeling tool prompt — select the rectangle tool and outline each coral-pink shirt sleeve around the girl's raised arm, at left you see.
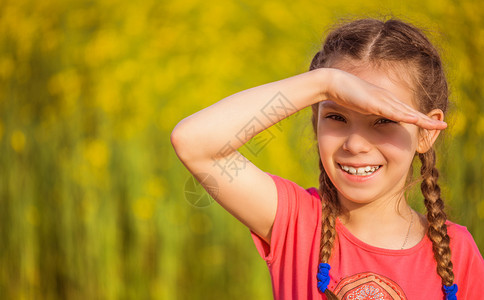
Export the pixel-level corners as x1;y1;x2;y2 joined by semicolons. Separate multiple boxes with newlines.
250;174;321;264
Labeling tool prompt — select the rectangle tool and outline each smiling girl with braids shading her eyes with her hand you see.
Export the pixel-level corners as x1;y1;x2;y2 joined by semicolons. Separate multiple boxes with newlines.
171;19;484;299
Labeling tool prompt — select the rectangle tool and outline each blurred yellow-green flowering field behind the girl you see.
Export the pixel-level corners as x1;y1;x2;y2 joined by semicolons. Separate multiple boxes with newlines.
0;0;484;299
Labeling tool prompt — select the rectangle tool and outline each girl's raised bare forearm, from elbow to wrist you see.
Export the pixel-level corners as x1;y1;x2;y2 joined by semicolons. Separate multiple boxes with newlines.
172;69;327;160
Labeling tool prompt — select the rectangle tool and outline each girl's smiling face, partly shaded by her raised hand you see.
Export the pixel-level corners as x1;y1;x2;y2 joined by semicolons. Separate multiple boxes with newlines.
318;68;419;207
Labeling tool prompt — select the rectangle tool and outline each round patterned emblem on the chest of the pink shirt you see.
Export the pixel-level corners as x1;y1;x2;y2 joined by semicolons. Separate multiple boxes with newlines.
334;272;407;300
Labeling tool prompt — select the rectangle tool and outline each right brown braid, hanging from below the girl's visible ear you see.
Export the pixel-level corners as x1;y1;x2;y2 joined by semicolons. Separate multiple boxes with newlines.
419;148;454;286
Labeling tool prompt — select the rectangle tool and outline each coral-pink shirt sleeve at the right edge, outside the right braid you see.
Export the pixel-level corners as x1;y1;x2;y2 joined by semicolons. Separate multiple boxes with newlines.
448;223;484;299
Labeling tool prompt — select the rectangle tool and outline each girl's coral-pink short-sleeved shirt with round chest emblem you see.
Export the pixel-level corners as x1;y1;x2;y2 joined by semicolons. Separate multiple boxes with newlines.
250;175;484;300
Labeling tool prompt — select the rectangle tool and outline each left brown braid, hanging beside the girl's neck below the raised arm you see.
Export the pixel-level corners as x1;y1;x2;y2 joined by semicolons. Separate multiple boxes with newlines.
319;160;339;300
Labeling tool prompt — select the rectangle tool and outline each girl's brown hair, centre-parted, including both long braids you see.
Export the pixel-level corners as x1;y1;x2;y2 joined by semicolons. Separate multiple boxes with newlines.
310;19;454;299
